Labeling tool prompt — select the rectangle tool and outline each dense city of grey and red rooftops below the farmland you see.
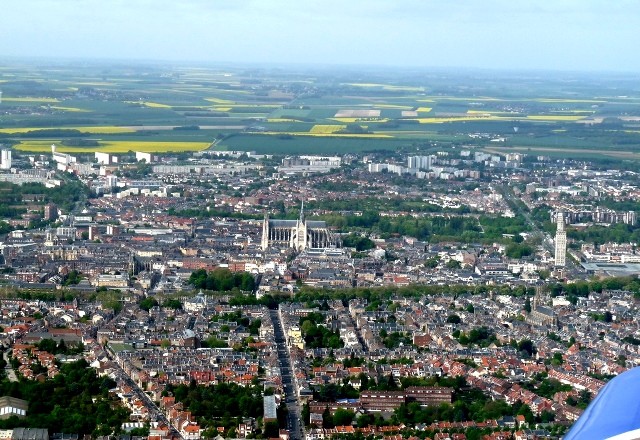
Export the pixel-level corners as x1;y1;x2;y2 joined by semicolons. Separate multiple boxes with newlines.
0;142;640;440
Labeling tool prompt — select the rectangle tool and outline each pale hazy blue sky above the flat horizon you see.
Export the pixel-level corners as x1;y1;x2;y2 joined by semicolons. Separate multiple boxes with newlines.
0;0;640;72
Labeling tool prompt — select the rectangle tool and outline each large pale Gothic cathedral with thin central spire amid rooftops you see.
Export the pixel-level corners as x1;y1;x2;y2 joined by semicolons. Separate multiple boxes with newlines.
262;201;339;252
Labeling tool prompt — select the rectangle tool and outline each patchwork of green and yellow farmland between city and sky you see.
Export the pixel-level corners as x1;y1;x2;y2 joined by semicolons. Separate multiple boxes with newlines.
0;64;640;160
